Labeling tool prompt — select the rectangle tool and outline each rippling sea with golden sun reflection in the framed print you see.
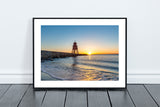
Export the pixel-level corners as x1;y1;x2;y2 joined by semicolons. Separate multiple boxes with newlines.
41;54;119;81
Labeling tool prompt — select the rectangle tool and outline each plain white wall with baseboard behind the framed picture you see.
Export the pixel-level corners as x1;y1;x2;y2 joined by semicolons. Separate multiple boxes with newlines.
0;0;160;83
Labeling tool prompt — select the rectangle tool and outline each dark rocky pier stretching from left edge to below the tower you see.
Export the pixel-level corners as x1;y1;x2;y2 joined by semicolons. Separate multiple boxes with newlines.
41;50;87;61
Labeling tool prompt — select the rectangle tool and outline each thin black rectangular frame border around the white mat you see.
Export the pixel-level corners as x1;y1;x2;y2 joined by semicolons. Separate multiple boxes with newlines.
32;17;127;90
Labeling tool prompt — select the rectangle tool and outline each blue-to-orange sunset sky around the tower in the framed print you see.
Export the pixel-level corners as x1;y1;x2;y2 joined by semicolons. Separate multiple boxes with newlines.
41;25;119;54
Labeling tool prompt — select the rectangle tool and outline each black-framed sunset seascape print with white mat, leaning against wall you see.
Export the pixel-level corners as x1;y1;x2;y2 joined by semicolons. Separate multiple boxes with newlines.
33;18;127;88
